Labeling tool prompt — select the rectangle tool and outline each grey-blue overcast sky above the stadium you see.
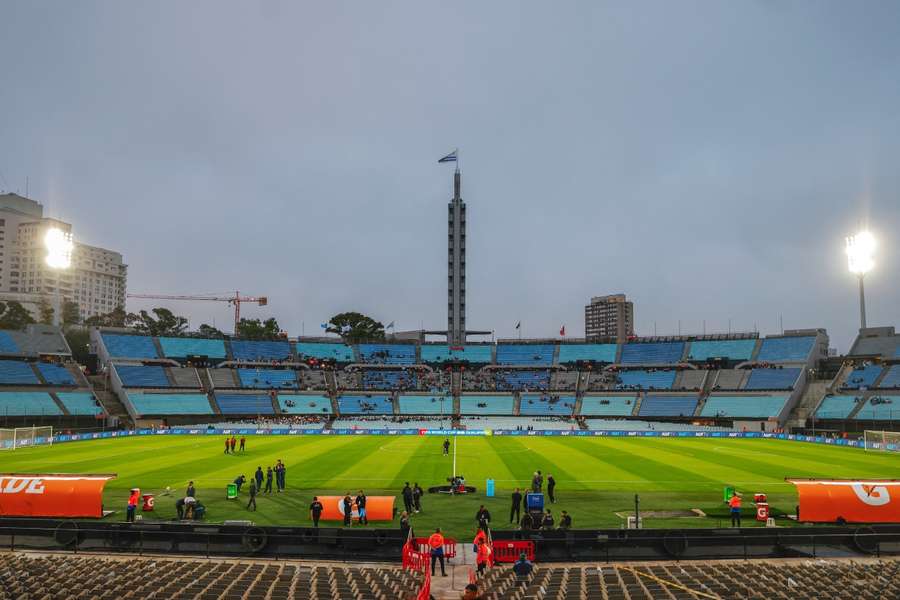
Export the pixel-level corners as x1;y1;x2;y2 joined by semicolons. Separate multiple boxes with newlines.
0;0;900;351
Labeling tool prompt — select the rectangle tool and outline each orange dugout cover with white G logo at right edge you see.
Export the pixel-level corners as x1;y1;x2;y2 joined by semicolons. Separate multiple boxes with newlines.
785;479;900;523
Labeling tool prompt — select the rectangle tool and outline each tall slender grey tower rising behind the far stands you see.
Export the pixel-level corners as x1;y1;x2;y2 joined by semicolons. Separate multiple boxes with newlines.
447;166;466;345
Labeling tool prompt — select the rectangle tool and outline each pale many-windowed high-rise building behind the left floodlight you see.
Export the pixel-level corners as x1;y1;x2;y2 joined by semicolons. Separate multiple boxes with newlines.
0;194;128;319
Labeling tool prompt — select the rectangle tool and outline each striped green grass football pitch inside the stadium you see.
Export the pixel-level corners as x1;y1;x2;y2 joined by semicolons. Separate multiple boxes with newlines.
8;436;900;538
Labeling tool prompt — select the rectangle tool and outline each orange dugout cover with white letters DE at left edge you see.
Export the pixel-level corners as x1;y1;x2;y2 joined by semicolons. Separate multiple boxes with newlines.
0;473;116;519
